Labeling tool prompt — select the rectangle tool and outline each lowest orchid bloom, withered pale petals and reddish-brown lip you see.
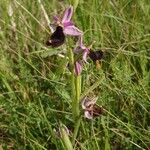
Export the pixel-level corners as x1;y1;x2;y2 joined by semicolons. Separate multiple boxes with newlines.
81;97;104;119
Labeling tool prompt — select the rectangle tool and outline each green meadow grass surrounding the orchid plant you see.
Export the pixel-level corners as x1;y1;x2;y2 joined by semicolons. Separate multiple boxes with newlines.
0;0;150;150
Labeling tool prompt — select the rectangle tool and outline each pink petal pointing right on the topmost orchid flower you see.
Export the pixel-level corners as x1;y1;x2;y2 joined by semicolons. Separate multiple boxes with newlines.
64;26;82;36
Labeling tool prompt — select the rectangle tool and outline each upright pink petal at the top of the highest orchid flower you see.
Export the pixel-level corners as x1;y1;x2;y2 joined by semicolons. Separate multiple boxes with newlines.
62;6;73;23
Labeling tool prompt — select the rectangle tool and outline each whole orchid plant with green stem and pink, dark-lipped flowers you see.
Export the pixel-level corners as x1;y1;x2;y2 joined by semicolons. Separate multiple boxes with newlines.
46;6;101;147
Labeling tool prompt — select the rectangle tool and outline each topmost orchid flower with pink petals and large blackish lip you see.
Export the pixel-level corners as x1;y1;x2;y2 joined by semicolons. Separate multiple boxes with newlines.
46;6;82;47
